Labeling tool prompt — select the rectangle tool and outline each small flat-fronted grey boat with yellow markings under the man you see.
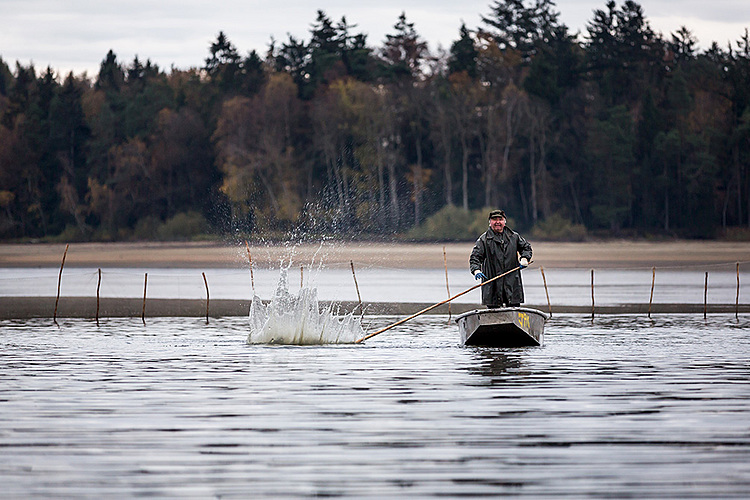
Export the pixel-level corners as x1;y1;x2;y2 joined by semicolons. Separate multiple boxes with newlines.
456;307;549;347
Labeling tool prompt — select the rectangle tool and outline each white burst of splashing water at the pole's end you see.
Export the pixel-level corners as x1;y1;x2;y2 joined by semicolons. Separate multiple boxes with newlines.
247;269;365;345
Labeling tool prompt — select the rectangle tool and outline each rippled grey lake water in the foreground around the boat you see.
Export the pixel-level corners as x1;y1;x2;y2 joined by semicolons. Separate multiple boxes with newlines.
0;315;750;499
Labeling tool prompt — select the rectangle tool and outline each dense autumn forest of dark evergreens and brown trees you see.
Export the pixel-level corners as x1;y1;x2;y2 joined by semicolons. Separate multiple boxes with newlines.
0;0;750;241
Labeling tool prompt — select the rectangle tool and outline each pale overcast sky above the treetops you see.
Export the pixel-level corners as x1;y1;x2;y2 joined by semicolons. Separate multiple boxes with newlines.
0;0;750;76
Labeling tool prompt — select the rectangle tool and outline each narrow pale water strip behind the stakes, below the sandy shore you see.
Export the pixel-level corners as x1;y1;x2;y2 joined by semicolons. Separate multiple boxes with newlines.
0;265;750;306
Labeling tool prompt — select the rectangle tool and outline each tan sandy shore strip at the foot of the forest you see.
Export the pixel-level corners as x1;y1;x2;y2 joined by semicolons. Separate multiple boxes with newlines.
0;240;750;269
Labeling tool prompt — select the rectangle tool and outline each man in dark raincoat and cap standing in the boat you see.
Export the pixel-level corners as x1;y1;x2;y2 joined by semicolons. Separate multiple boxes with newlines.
469;210;531;308
